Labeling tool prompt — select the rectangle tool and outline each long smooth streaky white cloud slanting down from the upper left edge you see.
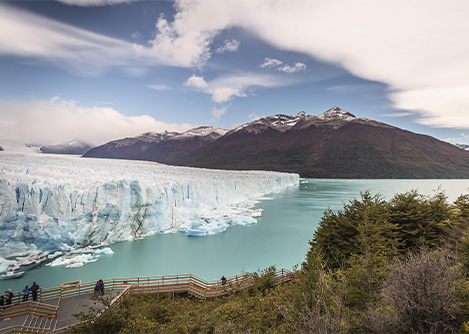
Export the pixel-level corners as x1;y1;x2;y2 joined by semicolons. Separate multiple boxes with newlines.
0;4;141;75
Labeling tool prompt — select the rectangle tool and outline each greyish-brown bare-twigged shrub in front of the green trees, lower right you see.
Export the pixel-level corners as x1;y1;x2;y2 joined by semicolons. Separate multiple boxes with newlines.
369;249;462;334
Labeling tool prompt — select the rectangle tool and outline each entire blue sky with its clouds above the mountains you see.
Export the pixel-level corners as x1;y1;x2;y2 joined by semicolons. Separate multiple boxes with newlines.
0;0;469;144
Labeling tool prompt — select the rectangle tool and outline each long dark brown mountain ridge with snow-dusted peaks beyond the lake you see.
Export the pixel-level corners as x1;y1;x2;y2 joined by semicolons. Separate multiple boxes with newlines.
85;107;469;178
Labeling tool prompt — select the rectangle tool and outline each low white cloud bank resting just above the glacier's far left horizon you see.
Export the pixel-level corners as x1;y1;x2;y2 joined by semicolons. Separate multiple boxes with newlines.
0;97;194;145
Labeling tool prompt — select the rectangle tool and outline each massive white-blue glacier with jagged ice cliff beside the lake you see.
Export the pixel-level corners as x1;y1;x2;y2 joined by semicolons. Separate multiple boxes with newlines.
0;143;299;272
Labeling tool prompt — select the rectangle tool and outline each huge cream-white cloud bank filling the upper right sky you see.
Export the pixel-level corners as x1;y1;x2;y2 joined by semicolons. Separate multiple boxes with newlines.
160;0;469;128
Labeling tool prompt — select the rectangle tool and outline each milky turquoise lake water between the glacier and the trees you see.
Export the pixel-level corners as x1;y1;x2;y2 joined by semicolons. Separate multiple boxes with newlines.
0;179;469;291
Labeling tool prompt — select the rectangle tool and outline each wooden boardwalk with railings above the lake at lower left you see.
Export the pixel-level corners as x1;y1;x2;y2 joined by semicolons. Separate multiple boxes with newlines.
0;269;293;334
